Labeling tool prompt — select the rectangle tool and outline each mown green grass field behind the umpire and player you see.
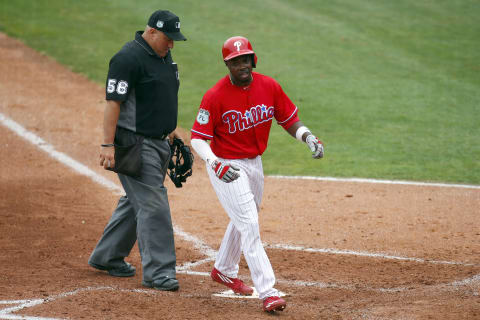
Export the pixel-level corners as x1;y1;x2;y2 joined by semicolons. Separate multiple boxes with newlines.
0;0;480;184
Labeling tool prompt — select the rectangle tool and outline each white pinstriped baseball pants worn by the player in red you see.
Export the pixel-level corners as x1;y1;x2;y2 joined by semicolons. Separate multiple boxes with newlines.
207;156;278;299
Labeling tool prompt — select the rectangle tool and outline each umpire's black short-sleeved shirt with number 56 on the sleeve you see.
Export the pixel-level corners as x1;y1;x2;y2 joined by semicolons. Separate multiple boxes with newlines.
106;31;180;138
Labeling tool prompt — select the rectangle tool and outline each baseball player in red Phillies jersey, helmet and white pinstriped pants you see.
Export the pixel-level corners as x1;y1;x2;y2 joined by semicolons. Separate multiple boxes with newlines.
191;36;323;312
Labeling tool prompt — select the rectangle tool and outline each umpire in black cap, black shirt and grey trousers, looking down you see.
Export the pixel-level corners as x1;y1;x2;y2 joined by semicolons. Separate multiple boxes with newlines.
88;10;186;291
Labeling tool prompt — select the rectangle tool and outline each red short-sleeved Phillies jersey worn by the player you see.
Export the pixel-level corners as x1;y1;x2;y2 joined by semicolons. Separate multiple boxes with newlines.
191;72;299;159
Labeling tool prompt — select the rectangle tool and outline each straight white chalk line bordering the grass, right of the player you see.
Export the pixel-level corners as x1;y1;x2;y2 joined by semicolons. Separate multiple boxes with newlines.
268;175;480;189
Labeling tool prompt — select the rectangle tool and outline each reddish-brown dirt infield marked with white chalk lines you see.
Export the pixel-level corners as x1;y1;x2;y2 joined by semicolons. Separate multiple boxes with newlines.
0;33;480;320
